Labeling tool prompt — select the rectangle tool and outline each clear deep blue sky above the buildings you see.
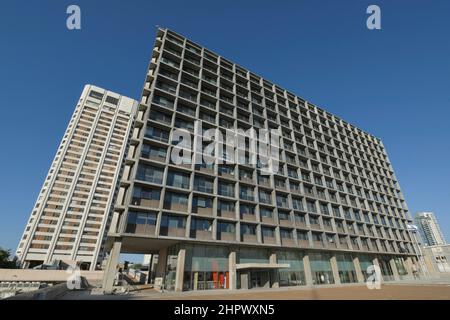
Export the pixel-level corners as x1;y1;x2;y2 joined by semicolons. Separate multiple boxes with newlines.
0;0;450;255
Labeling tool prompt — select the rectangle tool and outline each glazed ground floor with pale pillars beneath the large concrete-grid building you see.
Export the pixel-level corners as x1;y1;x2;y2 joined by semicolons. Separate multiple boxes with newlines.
142;243;416;291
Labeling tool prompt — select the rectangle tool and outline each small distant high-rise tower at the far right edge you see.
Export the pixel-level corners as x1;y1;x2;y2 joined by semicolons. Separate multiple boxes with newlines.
415;212;445;246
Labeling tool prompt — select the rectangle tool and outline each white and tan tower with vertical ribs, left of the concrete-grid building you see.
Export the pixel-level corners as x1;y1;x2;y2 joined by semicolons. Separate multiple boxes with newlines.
17;85;138;270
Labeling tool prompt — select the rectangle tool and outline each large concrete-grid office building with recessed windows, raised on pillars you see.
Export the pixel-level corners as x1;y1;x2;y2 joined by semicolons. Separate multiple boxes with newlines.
103;29;416;292
